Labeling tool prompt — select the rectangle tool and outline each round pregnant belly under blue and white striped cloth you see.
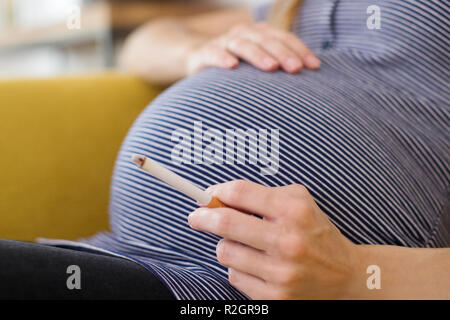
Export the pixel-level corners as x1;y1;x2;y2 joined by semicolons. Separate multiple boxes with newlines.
110;65;442;261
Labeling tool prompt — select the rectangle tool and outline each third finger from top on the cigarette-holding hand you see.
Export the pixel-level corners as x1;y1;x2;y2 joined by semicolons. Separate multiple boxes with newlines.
216;239;274;281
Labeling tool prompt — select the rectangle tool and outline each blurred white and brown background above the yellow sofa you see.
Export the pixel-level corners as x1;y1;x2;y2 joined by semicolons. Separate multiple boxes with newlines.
0;0;266;78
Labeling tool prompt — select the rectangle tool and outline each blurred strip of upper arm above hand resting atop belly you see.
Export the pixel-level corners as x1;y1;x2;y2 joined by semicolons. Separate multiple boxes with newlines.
184;8;253;36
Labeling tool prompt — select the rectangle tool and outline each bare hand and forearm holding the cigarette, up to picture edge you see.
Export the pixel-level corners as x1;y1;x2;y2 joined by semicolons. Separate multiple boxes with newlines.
188;180;450;299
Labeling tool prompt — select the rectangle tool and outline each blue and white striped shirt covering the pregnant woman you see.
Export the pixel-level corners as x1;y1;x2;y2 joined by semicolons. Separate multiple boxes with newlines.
70;0;450;299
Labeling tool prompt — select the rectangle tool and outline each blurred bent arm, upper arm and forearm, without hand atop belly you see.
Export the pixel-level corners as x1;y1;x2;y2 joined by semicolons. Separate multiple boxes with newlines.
120;8;253;84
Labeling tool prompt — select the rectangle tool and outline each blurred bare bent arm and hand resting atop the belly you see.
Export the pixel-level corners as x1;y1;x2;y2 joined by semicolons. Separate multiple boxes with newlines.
120;9;320;84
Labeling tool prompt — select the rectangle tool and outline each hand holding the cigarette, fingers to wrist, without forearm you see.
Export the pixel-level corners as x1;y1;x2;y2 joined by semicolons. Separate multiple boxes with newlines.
189;181;361;299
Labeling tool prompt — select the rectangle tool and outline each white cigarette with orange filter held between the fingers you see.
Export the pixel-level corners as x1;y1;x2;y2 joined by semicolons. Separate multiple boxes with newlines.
131;154;226;208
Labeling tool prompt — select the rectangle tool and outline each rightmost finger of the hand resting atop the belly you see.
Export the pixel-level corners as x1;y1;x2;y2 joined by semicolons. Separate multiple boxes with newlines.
267;28;320;69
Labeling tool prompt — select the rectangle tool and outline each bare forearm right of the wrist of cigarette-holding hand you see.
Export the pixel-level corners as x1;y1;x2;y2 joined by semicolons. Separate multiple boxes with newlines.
350;245;450;299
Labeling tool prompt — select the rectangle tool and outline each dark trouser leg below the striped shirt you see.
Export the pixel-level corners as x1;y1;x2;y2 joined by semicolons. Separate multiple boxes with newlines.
0;240;174;300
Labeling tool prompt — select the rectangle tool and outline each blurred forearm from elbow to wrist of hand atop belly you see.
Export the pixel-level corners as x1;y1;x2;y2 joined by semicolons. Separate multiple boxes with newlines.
120;19;209;84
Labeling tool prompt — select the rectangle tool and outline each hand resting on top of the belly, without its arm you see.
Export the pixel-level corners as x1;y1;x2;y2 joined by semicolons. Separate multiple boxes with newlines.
187;23;320;74
